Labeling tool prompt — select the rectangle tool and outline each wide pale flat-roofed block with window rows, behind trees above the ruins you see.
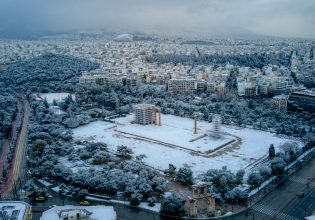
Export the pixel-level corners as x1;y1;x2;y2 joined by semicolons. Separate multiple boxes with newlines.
167;78;197;93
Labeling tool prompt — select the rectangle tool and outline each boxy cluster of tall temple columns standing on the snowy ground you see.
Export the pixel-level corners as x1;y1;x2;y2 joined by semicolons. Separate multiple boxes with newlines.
134;104;161;125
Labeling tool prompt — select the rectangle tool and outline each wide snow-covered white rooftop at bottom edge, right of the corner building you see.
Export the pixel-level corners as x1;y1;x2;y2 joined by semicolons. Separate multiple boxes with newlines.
40;205;117;220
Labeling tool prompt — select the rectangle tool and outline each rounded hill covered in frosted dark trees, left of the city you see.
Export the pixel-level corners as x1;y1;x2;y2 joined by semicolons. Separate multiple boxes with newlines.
0;54;99;92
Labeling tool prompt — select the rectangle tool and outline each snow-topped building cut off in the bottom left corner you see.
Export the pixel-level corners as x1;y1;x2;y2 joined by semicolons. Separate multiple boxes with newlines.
0;201;32;220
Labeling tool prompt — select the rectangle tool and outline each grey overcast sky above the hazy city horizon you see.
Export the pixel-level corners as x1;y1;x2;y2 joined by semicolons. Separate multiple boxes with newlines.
0;0;315;38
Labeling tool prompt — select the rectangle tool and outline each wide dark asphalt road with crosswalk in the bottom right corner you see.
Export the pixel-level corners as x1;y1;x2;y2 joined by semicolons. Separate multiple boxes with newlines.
224;157;315;220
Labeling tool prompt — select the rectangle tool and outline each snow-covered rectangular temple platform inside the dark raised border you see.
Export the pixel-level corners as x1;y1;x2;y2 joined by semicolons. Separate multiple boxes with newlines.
116;115;234;152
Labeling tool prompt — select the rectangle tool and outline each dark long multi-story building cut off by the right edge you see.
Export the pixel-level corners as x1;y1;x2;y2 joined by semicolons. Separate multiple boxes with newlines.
288;91;315;115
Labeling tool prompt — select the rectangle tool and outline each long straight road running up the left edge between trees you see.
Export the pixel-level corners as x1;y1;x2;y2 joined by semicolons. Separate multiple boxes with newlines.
1;99;30;199
